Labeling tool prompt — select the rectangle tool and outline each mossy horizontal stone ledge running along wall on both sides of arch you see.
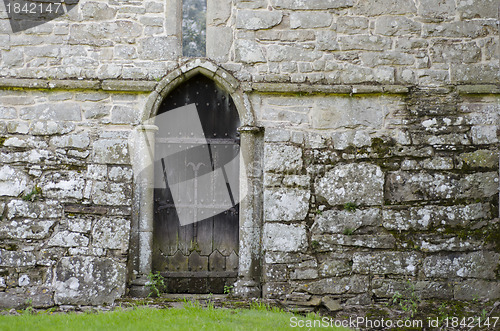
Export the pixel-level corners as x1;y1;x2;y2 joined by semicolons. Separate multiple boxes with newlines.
0;78;500;94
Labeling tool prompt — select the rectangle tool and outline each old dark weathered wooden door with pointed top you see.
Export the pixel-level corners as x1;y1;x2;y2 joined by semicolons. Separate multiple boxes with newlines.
153;75;239;293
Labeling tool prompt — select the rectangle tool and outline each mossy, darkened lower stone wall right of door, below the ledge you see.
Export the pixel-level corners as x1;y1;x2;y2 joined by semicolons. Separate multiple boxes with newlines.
260;88;500;306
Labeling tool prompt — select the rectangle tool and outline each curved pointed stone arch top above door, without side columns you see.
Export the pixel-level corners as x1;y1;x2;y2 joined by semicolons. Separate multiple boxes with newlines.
143;59;256;127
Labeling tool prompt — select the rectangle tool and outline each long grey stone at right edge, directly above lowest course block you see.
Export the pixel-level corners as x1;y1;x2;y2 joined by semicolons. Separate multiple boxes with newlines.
423;251;500;279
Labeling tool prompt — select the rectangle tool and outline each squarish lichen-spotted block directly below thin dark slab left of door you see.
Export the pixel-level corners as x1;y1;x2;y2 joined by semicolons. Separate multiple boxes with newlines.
92;218;130;253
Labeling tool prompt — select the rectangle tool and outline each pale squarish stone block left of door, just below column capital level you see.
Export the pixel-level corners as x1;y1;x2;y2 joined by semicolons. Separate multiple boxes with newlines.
92;139;130;164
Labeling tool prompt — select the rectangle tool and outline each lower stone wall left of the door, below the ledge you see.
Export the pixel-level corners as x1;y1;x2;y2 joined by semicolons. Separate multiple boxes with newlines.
0;90;144;308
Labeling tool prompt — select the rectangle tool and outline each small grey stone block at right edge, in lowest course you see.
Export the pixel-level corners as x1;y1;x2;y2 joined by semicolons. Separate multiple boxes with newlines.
454;279;500;300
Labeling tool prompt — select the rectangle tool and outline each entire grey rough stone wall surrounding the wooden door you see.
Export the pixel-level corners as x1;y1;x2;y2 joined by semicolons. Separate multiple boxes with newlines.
0;0;500;316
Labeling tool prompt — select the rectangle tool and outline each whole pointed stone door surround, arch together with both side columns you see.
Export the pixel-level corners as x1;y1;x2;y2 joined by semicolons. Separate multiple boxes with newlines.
129;59;263;297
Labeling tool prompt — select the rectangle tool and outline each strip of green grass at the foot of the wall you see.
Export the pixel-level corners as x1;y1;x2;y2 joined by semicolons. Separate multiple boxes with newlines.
0;304;348;331
